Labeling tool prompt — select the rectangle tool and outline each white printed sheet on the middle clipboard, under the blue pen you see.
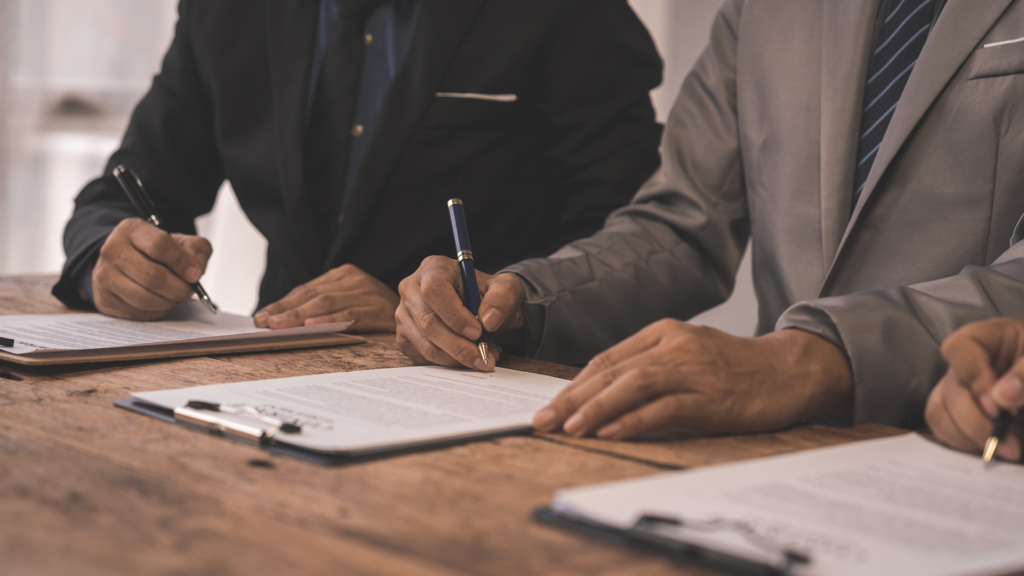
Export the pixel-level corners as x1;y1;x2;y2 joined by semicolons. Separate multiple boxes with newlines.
132;366;568;455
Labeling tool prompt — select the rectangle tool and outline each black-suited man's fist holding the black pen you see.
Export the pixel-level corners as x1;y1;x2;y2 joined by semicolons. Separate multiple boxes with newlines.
92;218;213;320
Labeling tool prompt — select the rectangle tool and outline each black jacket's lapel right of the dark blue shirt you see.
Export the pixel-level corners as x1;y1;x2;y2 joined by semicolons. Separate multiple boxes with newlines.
326;0;483;268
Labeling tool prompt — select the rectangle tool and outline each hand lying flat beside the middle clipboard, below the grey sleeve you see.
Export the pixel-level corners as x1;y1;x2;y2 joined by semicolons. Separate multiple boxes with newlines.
534;320;853;440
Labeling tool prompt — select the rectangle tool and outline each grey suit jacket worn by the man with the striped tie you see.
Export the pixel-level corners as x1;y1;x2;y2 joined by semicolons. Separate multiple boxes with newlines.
508;0;1024;424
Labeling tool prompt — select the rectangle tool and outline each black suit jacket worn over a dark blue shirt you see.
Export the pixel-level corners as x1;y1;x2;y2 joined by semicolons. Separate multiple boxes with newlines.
53;0;662;306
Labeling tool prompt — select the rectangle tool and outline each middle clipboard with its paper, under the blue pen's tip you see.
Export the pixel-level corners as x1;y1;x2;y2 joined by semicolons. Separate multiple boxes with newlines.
115;366;568;465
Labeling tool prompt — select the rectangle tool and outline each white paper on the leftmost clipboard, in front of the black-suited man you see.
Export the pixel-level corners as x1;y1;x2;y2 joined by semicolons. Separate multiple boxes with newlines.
0;299;351;356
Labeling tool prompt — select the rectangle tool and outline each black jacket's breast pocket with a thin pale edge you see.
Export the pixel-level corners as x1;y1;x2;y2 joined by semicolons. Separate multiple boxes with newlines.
422;92;525;130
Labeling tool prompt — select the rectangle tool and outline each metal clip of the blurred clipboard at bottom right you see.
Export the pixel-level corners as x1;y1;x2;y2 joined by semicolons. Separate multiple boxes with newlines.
626;515;811;576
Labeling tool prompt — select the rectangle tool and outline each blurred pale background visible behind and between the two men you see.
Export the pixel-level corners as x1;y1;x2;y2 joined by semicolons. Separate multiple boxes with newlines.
0;0;757;335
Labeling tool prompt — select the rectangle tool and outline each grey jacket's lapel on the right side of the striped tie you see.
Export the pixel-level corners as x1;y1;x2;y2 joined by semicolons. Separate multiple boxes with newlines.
821;0;1013;295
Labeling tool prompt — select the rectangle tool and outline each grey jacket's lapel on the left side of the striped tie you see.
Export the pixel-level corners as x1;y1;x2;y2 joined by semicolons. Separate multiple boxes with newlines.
820;0;881;270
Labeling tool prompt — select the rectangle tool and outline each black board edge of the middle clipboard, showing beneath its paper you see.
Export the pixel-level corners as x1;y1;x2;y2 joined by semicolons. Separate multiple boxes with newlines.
114;398;532;466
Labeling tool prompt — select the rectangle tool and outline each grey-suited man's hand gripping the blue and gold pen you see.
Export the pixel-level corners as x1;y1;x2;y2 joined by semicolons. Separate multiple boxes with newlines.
394;256;524;371
